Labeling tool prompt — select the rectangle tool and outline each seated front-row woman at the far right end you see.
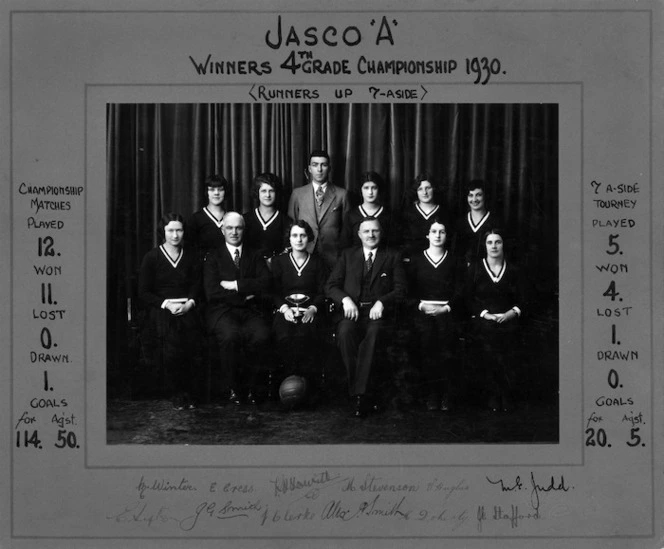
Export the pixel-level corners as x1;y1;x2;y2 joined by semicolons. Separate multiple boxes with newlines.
468;228;527;412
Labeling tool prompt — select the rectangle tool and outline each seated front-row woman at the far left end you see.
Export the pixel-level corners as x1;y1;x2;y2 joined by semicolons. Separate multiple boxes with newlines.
138;213;201;410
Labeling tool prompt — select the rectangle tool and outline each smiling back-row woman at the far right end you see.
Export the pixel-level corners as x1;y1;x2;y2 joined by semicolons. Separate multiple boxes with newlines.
452;179;504;266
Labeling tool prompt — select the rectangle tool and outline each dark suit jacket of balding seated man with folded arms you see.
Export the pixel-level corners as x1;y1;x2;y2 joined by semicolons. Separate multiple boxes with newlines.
203;245;270;327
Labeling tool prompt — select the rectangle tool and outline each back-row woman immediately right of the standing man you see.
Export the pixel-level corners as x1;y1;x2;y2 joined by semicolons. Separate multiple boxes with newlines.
341;172;392;248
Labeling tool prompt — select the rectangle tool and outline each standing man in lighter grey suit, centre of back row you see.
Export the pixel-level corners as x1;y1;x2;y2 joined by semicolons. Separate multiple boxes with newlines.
288;150;350;269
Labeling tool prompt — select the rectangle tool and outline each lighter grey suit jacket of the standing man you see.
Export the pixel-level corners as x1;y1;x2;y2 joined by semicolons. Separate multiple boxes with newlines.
288;183;350;268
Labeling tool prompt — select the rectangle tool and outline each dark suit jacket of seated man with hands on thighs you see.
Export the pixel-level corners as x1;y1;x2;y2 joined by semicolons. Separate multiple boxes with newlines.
325;247;408;316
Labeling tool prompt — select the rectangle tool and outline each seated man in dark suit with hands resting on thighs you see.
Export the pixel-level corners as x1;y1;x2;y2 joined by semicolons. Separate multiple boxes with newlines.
326;217;407;417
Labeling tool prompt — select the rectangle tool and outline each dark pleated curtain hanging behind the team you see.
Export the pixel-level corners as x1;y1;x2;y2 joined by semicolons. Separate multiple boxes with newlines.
107;103;558;372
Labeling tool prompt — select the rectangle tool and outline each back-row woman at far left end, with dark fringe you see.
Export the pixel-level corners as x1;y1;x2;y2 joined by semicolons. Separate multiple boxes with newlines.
187;175;229;261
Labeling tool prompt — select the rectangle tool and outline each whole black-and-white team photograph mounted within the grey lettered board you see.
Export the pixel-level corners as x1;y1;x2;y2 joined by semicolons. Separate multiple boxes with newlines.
107;103;559;444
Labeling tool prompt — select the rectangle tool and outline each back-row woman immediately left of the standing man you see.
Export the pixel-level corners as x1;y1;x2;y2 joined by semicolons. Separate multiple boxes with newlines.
243;173;290;266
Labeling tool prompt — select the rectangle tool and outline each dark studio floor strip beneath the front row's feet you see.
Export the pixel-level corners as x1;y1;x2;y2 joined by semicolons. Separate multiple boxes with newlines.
107;390;558;445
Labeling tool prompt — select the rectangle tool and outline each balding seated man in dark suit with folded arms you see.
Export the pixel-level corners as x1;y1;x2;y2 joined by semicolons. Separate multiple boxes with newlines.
203;212;270;405
